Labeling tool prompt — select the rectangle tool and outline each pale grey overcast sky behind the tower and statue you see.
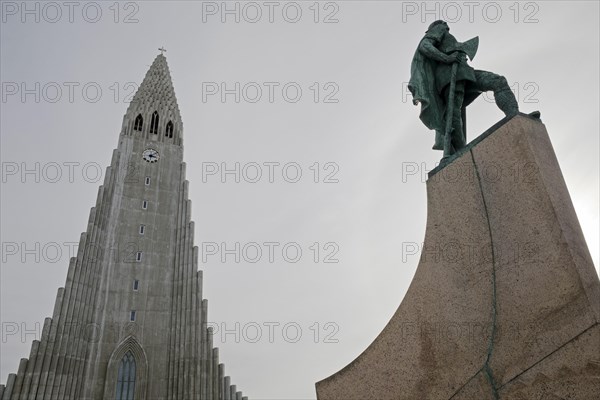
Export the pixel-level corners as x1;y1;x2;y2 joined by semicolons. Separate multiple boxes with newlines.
0;1;600;399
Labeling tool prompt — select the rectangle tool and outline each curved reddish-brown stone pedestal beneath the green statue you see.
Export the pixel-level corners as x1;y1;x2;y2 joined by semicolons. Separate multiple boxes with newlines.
316;114;600;400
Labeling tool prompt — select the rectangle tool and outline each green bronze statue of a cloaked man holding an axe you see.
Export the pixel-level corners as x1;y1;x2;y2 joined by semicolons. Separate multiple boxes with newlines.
408;20;539;159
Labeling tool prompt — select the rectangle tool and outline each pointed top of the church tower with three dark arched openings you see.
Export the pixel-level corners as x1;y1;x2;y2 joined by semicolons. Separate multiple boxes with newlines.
122;49;183;144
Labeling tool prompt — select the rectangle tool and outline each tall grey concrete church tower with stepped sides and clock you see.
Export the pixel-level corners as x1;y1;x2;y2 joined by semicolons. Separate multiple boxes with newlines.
0;54;245;400
